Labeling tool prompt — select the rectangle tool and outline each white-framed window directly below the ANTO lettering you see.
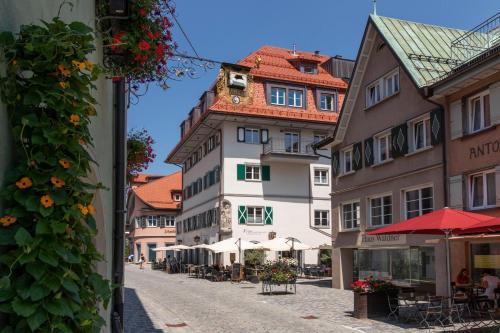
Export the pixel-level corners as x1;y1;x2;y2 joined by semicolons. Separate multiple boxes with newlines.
469;169;496;208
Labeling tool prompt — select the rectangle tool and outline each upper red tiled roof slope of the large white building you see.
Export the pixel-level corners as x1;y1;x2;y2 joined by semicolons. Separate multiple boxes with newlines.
238;46;347;89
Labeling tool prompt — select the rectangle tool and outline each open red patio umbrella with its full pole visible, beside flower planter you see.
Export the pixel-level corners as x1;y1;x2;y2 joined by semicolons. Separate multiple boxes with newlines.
367;207;492;296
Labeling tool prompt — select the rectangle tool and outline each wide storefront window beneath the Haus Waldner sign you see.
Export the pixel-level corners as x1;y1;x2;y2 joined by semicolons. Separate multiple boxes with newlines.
354;247;436;285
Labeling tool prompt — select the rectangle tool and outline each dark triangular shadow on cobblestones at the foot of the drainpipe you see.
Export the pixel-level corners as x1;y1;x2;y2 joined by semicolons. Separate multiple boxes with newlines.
123;287;164;333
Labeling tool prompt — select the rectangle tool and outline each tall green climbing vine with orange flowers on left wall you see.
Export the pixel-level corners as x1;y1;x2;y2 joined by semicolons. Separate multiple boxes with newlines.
0;18;111;332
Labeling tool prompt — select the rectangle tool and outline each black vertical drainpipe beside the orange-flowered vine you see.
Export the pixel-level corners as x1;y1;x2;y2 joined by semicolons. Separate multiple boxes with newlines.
111;78;127;333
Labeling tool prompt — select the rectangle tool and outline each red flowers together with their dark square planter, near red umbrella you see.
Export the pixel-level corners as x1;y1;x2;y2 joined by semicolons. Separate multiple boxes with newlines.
351;279;397;319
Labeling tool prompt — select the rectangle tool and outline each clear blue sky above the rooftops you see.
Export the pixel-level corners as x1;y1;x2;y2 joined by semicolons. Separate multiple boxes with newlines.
128;0;500;174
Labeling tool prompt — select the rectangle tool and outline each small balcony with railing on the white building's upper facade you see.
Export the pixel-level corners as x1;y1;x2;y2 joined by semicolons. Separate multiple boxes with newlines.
261;135;319;163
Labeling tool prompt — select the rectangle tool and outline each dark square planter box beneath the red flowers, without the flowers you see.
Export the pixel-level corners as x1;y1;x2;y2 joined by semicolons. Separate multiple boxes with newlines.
354;293;389;319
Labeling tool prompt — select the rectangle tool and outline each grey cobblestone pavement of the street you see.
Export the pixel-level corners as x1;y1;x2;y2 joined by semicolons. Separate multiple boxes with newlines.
125;264;458;333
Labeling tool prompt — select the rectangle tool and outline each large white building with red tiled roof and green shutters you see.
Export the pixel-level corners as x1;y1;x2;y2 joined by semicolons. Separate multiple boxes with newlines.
166;46;353;264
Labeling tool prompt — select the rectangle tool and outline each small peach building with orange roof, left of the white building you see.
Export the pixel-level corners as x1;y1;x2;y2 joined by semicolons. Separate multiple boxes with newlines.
126;171;182;261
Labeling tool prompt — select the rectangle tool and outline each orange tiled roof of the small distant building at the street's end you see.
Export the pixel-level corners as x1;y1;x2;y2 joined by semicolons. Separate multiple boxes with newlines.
132;171;182;209
